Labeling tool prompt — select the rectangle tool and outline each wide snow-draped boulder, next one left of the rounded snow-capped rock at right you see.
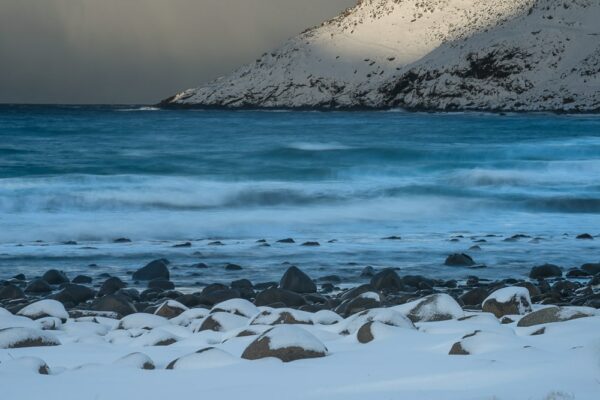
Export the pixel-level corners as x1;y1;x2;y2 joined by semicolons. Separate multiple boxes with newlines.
392;293;465;322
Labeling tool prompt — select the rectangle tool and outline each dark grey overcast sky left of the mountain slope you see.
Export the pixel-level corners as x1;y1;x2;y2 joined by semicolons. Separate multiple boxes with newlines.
0;0;356;103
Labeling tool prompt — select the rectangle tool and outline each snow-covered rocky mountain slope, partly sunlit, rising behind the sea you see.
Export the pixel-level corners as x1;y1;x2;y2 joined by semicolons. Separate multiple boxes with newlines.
162;0;600;111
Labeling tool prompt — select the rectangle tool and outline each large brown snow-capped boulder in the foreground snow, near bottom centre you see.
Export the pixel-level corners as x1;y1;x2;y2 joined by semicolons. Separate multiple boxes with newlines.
242;325;328;362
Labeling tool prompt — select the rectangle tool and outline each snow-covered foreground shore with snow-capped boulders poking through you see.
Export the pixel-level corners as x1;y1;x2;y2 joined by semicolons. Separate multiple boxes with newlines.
0;287;600;400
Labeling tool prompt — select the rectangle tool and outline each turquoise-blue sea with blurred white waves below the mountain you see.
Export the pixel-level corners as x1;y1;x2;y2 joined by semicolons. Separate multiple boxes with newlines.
0;106;600;284
